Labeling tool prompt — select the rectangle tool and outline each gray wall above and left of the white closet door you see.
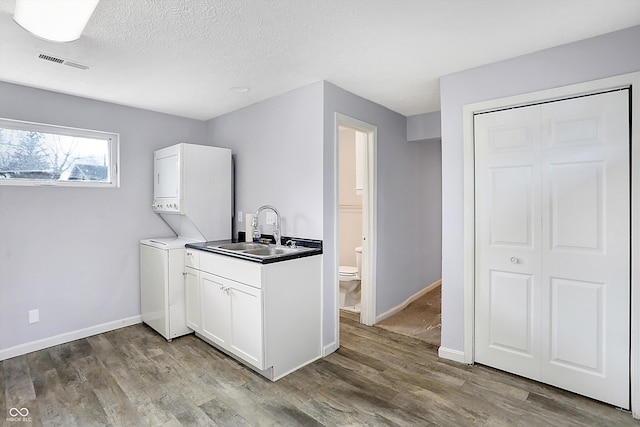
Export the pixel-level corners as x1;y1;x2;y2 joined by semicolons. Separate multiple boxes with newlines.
440;26;640;351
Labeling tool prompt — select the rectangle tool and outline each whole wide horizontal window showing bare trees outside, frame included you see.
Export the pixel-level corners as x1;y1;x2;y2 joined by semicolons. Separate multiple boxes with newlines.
0;119;119;187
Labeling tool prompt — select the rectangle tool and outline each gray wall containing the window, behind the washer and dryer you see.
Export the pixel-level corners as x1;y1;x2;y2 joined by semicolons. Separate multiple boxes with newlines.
0;82;206;351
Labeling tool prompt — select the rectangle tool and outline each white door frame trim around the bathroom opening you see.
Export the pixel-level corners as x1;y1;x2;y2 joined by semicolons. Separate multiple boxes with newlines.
333;113;378;330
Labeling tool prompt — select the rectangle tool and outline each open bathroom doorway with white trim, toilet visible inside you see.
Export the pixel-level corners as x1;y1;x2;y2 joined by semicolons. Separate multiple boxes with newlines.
335;114;376;325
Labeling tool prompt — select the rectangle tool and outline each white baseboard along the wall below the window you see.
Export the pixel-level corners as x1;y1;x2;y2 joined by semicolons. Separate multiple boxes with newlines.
0;315;142;360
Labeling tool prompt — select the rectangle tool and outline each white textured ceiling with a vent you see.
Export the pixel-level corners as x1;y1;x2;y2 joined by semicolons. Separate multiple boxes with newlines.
0;0;640;120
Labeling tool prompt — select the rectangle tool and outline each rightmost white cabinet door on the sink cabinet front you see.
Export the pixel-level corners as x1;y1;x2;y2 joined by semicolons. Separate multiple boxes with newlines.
229;283;265;369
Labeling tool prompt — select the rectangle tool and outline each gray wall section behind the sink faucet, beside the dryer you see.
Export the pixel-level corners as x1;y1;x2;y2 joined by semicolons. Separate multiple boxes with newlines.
207;82;322;239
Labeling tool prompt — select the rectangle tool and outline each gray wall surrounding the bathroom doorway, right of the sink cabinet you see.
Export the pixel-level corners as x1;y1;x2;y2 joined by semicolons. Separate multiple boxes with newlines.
324;82;441;344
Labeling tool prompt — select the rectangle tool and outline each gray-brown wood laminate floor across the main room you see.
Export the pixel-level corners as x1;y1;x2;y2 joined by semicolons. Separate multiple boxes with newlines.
0;313;640;427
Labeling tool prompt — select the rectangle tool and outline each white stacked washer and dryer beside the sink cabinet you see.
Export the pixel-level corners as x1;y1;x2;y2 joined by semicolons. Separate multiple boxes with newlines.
140;143;233;340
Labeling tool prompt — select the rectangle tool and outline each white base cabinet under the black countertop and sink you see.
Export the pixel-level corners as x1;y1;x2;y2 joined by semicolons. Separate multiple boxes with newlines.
185;249;322;381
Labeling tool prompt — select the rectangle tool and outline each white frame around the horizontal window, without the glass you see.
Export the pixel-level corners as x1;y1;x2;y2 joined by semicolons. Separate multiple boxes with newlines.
0;118;120;188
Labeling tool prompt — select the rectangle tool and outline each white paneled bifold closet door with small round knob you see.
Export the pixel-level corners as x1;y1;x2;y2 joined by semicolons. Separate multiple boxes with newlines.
475;90;630;408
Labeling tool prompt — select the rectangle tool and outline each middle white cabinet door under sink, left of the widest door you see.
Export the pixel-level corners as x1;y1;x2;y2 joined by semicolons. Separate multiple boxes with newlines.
200;272;230;348
